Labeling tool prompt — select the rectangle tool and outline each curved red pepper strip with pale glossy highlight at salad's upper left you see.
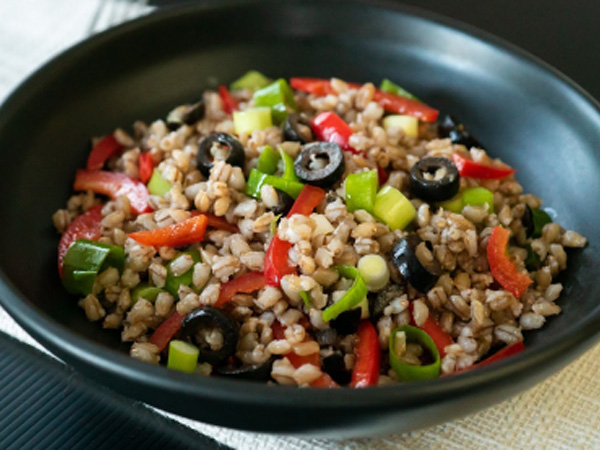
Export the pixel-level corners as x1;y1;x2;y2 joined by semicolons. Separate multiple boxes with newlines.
73;169;152;214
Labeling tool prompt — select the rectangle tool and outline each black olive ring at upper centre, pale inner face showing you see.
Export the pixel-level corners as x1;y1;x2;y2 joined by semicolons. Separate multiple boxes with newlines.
294;142;346;188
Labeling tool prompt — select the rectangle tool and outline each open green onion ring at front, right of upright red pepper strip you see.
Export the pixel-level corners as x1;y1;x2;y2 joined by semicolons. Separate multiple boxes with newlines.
389;325;441;381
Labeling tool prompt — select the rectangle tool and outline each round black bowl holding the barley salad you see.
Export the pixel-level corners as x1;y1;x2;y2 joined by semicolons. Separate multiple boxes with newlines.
0;0;600;436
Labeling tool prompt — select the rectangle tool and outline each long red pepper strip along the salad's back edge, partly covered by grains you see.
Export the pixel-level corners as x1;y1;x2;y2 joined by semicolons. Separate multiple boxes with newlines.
290;78;439;122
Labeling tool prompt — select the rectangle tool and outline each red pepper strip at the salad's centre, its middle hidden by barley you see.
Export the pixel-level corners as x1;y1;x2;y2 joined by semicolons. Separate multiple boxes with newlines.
265;184;325;286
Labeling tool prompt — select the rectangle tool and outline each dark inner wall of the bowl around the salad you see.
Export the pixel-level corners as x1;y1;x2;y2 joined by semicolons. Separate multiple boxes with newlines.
0;1;600;436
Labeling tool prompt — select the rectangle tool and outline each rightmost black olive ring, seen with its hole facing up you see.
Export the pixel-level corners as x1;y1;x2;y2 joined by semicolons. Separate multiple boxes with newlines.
410;158;460;202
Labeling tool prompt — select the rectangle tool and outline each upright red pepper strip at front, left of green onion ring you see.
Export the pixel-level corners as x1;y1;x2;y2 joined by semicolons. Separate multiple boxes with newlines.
350;320;381;388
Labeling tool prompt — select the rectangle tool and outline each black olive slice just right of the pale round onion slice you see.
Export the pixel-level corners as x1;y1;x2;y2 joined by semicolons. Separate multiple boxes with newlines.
391;233;442;293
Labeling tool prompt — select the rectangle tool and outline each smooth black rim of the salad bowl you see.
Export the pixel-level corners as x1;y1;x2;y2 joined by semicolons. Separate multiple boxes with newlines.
0;0;600;409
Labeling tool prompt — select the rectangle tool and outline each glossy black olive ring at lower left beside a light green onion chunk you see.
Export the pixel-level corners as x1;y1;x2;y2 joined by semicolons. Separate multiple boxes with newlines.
181;306;239;364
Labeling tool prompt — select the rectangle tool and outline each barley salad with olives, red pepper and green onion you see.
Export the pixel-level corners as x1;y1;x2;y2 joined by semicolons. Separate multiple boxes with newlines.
53;71;586;387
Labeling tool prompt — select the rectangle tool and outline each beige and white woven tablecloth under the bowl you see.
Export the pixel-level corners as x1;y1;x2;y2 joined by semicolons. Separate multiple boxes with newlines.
0;0;600;450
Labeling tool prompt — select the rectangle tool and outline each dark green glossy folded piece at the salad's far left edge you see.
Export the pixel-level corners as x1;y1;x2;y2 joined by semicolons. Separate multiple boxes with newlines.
62;239;125;295
